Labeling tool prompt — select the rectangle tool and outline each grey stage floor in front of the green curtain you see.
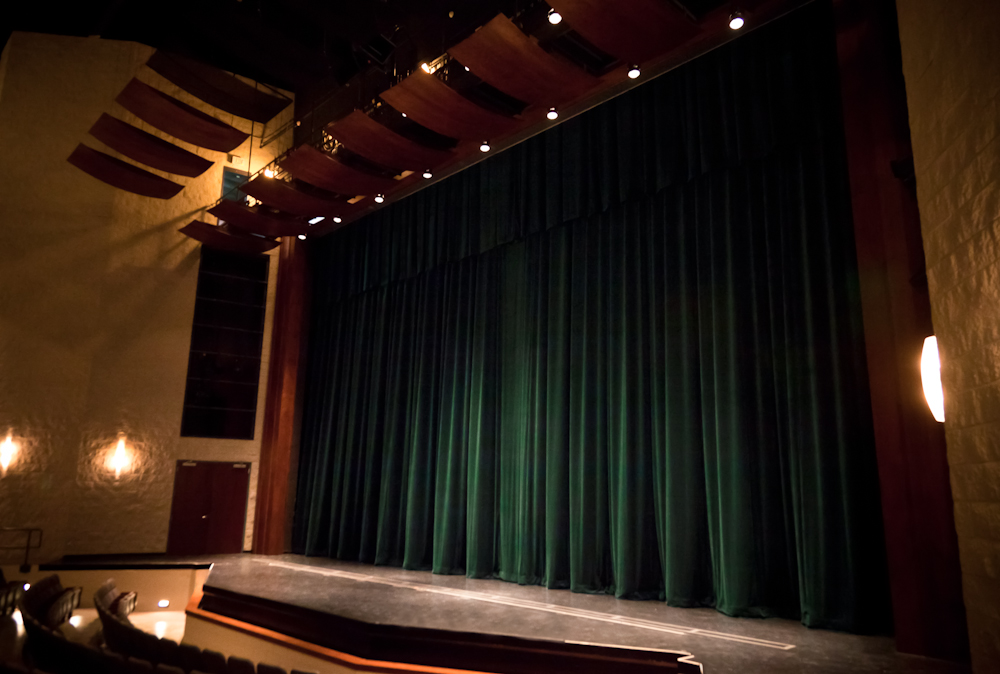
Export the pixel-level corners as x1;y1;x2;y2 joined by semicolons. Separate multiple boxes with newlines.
199;555;969;674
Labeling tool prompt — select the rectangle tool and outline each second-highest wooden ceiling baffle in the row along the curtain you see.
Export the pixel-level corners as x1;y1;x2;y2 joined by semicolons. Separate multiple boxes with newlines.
448;14;598;105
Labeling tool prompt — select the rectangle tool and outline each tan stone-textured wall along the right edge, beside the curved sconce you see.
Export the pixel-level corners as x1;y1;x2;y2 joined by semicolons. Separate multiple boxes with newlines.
896;0;1000;674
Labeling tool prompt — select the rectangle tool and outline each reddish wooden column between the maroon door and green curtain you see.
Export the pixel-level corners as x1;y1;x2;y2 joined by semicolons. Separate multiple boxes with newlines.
253;236;309;555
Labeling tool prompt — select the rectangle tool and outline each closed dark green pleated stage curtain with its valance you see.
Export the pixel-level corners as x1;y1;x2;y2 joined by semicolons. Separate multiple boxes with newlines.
293;3;888;631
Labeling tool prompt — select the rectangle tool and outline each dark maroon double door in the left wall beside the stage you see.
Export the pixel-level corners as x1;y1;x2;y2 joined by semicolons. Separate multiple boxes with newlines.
167;461;250;555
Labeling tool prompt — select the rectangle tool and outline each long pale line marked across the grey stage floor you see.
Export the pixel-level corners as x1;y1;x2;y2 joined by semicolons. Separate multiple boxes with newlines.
251;559;795;651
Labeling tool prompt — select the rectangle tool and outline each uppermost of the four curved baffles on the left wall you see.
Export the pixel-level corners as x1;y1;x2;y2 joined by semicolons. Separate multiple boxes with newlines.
146;51;292;122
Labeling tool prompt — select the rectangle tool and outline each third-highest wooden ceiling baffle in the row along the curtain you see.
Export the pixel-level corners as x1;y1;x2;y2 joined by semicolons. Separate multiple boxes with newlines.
379;69;517;140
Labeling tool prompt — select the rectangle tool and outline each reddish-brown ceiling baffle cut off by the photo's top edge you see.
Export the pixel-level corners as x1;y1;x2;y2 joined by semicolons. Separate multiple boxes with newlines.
549;0;700;63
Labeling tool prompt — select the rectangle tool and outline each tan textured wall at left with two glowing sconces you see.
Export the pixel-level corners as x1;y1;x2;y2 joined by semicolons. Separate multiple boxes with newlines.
0;33;292;560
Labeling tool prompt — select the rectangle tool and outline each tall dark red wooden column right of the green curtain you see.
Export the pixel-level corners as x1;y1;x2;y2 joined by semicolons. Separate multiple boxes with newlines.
834;0;968;659
